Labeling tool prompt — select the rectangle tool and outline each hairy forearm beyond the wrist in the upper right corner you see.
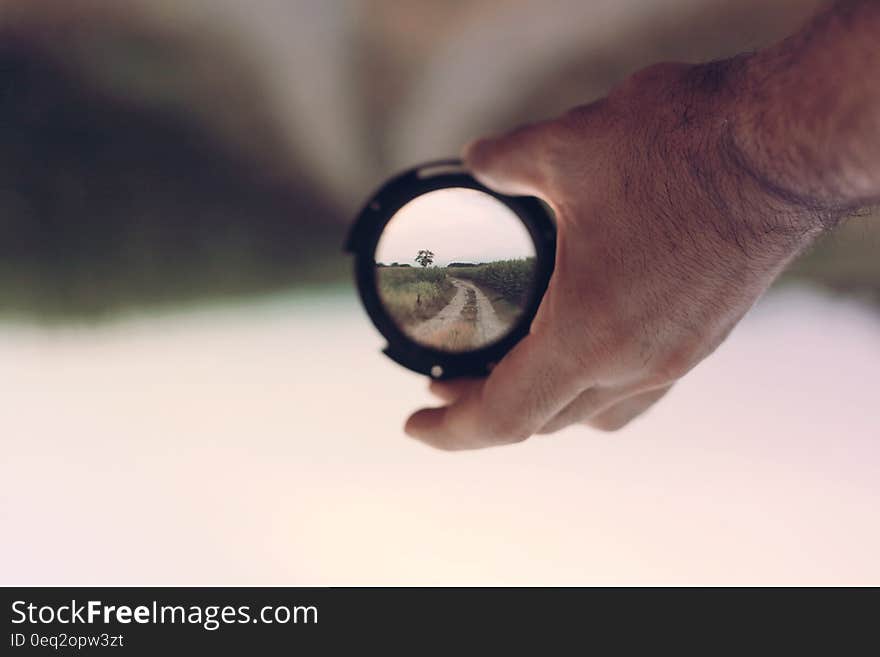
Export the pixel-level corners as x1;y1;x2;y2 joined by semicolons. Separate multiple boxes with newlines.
734;0;880;215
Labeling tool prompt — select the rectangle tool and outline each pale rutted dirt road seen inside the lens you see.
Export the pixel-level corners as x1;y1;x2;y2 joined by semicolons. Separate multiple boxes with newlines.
409;276;509;351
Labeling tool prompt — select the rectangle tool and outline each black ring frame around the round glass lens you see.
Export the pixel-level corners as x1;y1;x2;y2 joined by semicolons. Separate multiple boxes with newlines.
345;160;556;379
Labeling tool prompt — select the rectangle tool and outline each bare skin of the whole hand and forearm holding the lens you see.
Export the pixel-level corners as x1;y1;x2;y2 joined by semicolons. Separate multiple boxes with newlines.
406;0;880;450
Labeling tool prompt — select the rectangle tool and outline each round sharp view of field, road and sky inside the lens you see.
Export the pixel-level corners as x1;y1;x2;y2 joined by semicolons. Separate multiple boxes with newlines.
376;188;535;352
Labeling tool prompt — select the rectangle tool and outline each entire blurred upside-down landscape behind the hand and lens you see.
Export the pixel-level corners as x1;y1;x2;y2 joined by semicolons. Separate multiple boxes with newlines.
0;0;880;584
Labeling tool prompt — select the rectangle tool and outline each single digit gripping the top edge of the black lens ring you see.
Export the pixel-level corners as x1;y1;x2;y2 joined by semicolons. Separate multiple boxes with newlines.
461;122;550;196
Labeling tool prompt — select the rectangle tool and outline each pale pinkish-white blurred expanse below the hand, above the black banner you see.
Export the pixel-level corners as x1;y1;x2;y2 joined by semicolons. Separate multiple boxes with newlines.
0;291;880;584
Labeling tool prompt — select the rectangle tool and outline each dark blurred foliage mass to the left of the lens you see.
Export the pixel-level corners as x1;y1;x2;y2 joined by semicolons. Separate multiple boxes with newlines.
0;39;348;319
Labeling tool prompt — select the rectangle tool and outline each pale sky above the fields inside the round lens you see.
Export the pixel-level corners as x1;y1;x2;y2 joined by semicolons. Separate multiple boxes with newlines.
376;187;535;266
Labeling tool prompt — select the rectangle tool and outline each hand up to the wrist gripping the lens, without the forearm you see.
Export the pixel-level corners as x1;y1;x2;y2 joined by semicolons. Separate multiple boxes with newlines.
406;60;821;449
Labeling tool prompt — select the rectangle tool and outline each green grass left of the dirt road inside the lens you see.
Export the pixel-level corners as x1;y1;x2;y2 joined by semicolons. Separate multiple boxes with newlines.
376;266;455;327
